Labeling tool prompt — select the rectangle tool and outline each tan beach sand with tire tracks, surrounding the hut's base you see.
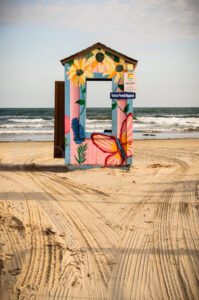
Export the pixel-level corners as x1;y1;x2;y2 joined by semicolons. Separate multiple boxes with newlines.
0;139;199;300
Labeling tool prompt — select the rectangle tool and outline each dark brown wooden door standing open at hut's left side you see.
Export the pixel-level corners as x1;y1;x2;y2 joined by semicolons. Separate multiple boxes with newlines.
54;81;65;158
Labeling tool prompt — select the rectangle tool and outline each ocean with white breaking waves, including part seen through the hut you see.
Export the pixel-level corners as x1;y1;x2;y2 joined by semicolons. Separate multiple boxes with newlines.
0;107;199;141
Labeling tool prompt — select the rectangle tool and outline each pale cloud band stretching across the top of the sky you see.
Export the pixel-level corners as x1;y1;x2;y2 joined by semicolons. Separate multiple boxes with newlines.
0;0;199;42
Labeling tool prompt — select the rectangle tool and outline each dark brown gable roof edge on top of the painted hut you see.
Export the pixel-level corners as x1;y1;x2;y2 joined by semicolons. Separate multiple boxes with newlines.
60;43;138;66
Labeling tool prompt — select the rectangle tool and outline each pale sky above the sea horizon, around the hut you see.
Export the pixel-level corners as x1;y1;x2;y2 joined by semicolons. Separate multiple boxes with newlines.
0;0;199;107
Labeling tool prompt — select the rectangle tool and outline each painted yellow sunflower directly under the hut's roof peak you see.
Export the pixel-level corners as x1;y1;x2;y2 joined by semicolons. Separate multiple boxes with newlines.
87;49;113;73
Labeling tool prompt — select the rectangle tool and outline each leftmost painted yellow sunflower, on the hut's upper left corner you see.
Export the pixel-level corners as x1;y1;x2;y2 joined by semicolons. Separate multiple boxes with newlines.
66;58;93;86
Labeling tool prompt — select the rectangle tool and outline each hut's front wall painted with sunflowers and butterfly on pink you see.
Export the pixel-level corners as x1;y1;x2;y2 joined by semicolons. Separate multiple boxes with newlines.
65;48;134;167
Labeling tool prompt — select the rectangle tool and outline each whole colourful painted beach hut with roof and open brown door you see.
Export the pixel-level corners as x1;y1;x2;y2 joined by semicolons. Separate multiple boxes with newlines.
54;43;137;169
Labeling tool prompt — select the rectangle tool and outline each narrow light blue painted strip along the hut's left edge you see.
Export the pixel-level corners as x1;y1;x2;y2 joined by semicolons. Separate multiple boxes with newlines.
64;64;71;164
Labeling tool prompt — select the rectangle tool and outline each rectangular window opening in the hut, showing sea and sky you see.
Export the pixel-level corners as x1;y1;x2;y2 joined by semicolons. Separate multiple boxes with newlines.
86;78;112;133
